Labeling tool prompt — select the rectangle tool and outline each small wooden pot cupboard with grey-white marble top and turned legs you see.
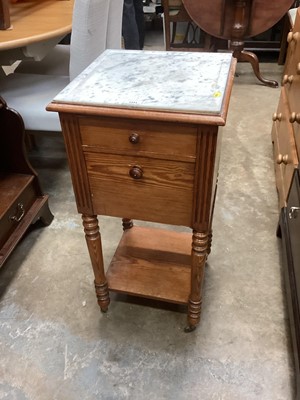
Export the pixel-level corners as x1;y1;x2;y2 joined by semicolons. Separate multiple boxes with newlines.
48;50;235;331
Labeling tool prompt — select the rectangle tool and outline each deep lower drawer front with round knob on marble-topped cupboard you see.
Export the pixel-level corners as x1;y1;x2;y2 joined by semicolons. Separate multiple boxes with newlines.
85;153;195;226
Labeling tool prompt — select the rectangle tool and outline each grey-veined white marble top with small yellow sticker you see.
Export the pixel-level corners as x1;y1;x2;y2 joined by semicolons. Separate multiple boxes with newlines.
54;50;232;114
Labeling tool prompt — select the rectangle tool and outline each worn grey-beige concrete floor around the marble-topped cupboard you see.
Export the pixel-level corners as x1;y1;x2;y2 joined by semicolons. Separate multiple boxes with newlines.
0;28;294;400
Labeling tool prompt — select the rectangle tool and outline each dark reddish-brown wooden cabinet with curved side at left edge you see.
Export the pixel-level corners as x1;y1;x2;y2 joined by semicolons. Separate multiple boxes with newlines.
0;97;53;267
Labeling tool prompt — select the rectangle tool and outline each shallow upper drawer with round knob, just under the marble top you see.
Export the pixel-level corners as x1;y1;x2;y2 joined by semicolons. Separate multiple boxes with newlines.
79;117;197;161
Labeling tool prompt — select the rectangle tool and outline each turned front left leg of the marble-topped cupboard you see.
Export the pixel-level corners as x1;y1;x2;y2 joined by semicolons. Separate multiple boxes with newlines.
82;215;109;312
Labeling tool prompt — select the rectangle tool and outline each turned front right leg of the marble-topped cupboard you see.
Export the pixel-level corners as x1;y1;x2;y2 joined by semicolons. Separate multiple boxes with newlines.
185;231;208;332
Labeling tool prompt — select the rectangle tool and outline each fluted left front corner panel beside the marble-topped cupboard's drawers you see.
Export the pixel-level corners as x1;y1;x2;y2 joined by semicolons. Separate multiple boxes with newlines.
60;114;94;215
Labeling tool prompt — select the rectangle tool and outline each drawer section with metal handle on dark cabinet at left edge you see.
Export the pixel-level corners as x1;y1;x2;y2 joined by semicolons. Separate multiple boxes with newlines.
0;174;36;248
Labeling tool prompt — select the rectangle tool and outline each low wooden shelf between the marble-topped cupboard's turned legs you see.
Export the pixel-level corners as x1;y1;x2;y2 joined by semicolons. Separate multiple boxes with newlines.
106;226;192;304
